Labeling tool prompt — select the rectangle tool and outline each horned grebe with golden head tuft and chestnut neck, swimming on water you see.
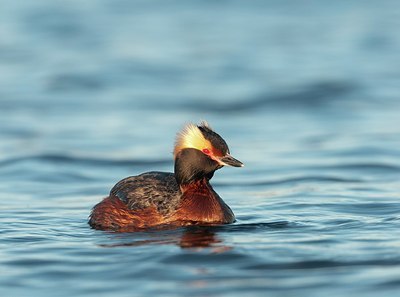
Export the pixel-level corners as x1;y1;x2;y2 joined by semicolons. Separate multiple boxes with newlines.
89;121;243;231
